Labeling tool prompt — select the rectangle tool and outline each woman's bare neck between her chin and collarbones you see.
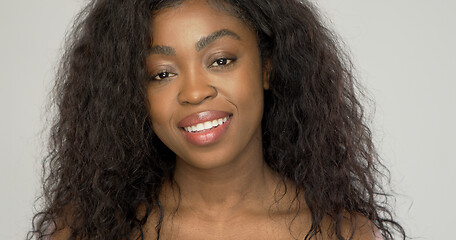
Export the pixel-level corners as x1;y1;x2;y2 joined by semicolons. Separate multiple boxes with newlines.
165;141;278;215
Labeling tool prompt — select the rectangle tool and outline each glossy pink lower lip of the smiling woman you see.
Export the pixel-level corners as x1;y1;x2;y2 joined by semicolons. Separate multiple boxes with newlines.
181;116;231;146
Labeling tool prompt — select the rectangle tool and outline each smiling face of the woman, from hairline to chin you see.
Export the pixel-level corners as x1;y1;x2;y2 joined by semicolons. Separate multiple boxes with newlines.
146;0;268;169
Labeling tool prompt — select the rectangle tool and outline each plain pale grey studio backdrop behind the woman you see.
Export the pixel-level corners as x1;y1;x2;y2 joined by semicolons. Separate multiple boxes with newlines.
0;0;456;239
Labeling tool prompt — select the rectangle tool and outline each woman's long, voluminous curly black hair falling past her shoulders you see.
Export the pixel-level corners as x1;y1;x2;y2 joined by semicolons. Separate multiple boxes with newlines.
27;0;406;240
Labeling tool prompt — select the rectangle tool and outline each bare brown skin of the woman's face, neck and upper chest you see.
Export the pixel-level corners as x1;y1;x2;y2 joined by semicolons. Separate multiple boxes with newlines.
53;0;380;240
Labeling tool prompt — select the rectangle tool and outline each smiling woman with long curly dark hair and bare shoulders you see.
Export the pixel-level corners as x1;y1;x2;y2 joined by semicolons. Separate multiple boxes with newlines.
29;0;405;240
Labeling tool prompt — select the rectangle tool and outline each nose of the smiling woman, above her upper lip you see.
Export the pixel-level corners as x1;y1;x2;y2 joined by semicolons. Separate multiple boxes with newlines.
177;68;218;105
